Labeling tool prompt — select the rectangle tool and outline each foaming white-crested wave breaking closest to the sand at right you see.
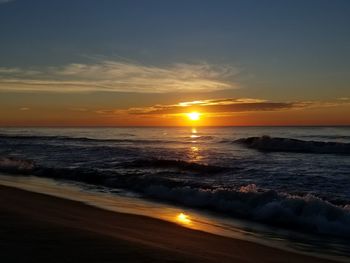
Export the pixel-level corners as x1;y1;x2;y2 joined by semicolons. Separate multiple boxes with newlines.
146;184;350;238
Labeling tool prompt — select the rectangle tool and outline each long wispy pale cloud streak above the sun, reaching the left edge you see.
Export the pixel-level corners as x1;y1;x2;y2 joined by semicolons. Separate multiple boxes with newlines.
0;61;239;93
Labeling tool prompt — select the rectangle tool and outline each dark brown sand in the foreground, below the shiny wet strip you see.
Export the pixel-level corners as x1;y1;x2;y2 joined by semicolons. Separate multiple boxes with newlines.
0;186;331;263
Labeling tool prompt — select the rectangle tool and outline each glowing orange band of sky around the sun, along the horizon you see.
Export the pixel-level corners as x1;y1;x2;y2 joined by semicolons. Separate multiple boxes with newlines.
0;99;350;126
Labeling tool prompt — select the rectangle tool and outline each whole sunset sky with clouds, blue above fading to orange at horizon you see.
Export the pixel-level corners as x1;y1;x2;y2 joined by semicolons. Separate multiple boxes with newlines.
0;0;350;126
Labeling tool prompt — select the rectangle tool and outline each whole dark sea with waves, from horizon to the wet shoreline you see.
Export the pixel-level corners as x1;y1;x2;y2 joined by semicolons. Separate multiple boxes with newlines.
0;127;350;240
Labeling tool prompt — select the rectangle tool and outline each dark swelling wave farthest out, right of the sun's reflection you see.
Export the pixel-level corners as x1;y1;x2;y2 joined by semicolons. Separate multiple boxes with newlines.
234;136;350;155
